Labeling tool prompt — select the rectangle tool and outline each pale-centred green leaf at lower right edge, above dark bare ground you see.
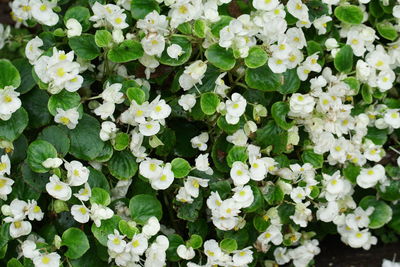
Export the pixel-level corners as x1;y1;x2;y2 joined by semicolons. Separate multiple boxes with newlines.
359;196;393;229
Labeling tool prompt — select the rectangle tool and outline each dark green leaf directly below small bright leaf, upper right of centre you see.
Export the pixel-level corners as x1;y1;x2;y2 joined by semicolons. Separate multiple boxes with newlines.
245;64;281;92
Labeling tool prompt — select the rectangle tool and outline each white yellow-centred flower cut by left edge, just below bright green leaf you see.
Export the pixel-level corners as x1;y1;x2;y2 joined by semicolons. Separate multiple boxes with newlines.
0;86;22;120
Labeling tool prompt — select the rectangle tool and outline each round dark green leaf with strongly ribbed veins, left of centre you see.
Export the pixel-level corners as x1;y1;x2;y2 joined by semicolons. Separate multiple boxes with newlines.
108;150;138;180
